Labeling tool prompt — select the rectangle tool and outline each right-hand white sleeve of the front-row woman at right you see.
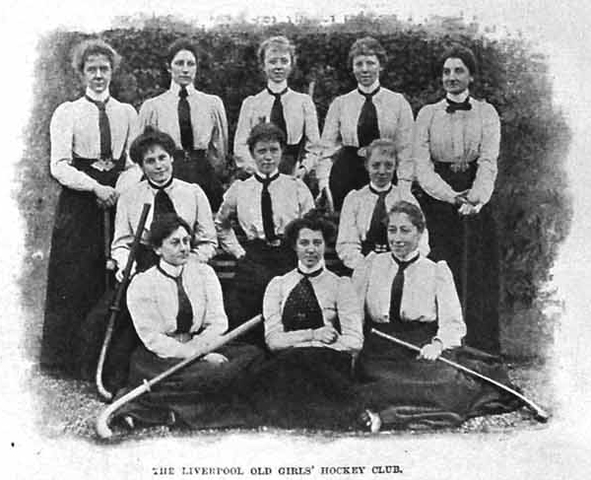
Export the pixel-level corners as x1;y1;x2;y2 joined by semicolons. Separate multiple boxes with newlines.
435;260;466;348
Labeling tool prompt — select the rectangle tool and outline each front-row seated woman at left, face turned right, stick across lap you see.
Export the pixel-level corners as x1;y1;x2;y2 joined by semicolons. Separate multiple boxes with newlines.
115;215;262;427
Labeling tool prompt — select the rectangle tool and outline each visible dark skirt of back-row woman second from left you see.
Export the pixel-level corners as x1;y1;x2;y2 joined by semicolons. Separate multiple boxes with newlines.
173;150;224;213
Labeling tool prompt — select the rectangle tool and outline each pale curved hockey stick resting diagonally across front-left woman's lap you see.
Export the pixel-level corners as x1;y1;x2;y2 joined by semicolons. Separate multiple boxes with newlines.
95;314;263;439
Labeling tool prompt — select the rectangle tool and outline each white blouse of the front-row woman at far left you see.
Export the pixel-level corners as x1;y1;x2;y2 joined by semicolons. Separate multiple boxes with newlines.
127;260;228;358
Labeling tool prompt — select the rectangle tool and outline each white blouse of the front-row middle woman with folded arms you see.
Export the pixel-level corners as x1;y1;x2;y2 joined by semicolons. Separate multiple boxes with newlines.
263;269;363;353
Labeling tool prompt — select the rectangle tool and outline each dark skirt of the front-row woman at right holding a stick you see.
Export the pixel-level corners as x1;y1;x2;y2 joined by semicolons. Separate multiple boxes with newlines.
357;322;521;429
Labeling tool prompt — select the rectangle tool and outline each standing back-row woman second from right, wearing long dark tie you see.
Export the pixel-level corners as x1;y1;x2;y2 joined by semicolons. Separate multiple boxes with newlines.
317;37;414;210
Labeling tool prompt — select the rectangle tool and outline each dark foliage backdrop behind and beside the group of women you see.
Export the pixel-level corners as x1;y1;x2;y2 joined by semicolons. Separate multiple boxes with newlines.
18;15;572;356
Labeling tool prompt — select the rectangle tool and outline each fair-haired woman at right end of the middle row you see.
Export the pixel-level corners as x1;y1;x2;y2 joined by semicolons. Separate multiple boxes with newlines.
336;139;429;270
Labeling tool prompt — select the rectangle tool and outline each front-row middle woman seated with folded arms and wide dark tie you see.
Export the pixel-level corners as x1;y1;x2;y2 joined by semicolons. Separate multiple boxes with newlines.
247;214;363;428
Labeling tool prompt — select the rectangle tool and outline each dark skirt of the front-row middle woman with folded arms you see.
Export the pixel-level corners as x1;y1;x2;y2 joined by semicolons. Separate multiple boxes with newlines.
251;347;356;430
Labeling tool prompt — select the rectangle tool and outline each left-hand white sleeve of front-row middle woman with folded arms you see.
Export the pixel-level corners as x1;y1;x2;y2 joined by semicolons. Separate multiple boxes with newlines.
263;277;313;351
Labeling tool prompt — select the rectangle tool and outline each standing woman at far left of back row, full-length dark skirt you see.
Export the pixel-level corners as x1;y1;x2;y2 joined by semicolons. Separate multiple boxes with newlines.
41;39;136;377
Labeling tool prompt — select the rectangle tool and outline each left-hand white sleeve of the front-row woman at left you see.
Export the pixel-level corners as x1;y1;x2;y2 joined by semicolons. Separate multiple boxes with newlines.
127;274;194;358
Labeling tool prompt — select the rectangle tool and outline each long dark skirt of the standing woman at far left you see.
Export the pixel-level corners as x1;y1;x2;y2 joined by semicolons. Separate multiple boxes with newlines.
40;163;119;377
